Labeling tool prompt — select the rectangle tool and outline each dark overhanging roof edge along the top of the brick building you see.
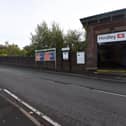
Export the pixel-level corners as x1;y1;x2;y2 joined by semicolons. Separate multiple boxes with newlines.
80;8;126;25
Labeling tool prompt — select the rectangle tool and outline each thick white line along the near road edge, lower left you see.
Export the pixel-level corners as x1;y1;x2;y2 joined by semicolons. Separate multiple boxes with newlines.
3;89;61;126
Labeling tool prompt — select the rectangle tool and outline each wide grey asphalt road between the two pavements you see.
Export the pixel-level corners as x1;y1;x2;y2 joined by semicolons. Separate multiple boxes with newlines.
0;66;126;126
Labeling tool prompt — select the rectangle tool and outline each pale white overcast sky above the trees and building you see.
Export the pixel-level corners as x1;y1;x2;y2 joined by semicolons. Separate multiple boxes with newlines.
0;0;126;47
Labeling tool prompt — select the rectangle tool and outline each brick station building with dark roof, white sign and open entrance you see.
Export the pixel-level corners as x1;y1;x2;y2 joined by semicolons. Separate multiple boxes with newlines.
80;9;126;70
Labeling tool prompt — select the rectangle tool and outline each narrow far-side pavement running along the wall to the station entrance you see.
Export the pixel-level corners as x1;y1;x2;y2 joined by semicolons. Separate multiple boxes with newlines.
0;65;126;83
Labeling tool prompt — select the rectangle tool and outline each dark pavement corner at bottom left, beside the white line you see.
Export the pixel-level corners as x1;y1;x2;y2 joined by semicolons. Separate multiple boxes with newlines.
0;92;36;126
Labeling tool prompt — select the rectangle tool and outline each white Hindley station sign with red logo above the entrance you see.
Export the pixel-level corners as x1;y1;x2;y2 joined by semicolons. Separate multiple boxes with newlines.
97;32;126;43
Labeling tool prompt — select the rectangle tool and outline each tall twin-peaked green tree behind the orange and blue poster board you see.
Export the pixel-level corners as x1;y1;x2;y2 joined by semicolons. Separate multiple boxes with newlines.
31;22;64;49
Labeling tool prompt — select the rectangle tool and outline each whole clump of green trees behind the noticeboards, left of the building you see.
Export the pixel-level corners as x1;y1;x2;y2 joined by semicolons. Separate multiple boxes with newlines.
27;22;86;56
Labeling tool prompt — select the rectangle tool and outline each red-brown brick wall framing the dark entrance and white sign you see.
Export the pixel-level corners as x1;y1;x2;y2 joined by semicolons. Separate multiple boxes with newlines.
86;20;126;70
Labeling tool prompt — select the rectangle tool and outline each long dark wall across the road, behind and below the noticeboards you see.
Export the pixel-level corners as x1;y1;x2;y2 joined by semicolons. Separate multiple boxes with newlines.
0;53;85;73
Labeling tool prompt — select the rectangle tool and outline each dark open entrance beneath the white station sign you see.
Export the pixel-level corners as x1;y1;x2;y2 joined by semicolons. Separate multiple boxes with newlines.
97;41;126;69
